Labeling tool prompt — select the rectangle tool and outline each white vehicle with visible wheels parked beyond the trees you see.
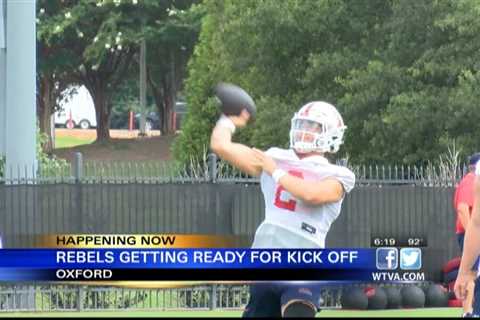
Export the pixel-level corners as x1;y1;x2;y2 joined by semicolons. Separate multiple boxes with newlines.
55;86;97;129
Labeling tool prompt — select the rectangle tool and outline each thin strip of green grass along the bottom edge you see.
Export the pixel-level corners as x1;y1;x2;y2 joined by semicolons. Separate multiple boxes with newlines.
0;308;462;318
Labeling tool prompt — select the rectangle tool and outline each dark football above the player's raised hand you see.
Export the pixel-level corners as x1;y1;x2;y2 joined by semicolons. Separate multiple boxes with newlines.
215;82;257;117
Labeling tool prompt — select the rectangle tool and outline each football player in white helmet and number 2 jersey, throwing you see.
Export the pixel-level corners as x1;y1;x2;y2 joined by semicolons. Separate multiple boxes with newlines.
210;101;355;317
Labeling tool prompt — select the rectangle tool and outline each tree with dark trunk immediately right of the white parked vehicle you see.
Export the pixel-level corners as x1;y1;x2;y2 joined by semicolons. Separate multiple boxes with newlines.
38;0;141;141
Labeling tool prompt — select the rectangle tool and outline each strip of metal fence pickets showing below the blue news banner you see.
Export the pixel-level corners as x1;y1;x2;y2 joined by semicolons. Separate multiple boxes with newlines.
0;284;352;312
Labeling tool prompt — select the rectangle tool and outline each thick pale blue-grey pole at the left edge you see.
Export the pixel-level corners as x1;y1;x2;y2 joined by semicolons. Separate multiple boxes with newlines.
4;0;37;179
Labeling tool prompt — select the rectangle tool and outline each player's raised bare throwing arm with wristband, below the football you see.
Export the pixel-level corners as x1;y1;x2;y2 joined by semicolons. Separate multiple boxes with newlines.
210;110;262;177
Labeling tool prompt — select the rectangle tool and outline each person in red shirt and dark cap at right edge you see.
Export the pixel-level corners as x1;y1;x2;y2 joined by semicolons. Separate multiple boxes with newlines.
453;153;480;317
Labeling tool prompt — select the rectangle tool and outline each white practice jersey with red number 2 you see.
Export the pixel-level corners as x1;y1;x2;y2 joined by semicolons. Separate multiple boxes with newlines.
252;148;355;248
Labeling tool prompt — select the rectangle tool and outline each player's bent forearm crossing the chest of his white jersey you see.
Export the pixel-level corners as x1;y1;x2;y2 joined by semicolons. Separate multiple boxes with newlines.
253;149;344;205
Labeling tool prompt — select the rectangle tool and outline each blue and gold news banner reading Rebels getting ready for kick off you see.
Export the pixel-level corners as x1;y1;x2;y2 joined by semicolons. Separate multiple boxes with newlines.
0;234;426;282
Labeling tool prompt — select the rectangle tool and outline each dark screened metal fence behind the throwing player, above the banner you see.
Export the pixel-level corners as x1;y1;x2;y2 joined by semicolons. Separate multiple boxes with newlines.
0;156;465;312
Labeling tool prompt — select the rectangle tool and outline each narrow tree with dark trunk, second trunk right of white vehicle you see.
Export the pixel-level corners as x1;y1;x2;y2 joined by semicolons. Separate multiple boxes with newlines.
145;0;204;134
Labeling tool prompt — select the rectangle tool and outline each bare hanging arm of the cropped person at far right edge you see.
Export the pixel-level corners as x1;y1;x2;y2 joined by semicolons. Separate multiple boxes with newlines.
455;176;480;300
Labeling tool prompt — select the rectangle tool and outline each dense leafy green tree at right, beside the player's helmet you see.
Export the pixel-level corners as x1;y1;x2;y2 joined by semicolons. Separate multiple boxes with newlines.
340;0;480;164
